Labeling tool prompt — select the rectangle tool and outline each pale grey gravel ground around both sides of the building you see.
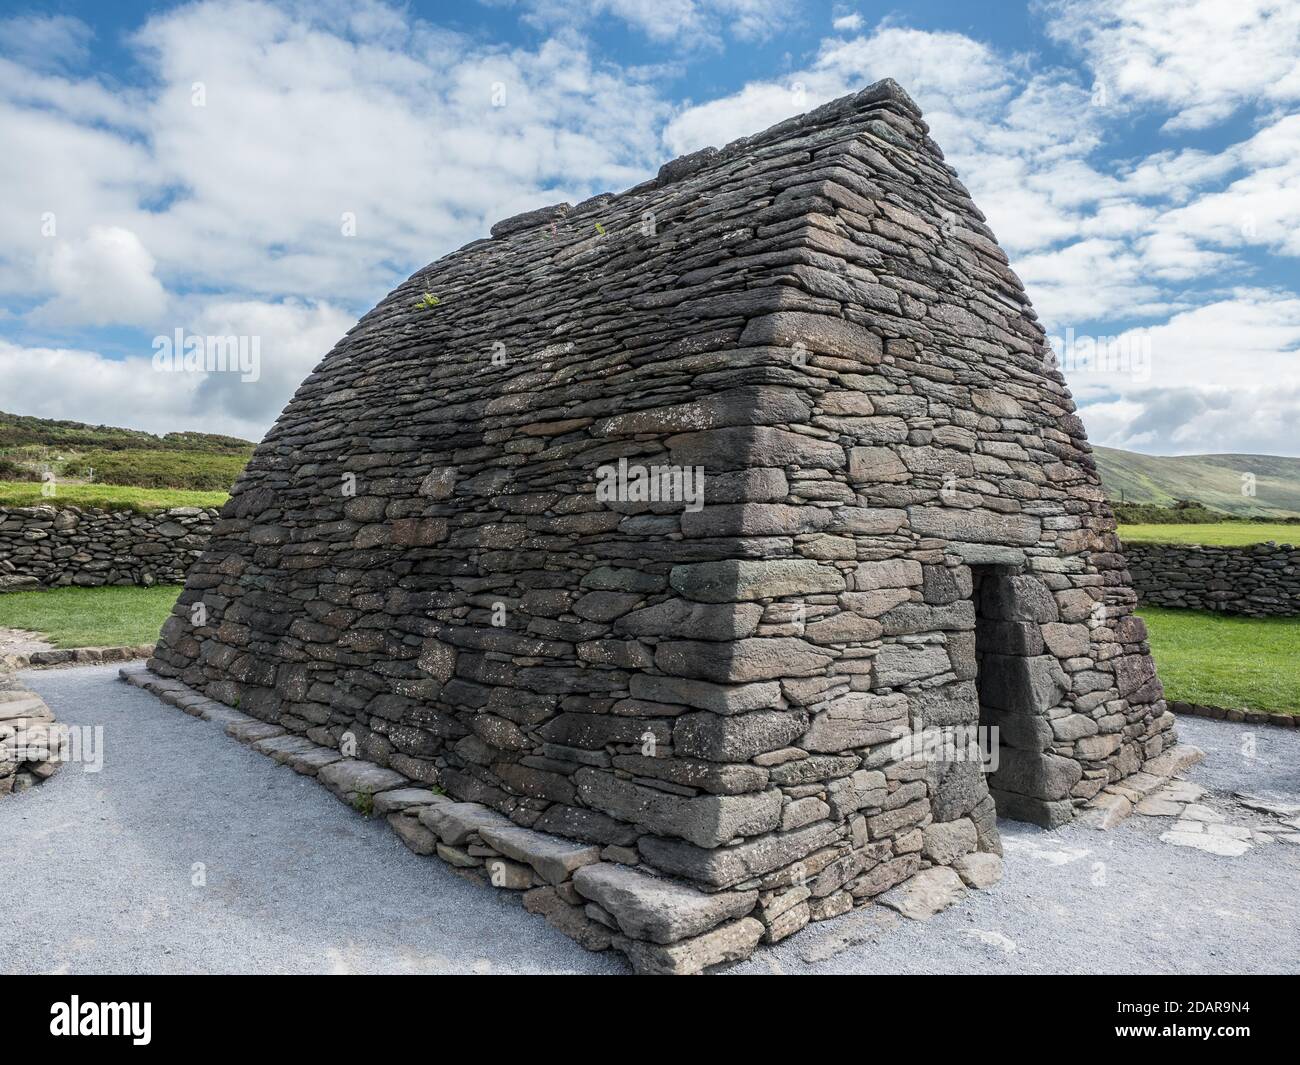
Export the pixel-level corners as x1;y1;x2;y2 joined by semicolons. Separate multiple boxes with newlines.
0;666;1300;974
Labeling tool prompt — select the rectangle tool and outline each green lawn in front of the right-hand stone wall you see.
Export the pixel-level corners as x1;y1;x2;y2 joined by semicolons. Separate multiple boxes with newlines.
1138;606;1300;714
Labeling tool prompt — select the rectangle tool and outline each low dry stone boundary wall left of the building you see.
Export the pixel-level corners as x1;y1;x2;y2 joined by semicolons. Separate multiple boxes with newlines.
0;506;218;592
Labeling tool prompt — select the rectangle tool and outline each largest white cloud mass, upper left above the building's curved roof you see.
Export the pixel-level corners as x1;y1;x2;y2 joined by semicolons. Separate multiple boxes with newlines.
0;0;664;321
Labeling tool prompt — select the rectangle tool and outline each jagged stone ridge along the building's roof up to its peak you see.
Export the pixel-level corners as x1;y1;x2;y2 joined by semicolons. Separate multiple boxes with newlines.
490;78;928;239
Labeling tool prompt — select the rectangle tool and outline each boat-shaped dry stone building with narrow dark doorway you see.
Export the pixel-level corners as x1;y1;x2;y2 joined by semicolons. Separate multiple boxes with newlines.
150;82;1174;971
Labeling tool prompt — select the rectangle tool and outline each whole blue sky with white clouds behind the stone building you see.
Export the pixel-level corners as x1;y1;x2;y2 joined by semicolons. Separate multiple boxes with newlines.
0;0;1300;455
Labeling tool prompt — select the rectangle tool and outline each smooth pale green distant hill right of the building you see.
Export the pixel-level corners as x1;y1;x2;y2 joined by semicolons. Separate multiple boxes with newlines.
1093;447;1300;518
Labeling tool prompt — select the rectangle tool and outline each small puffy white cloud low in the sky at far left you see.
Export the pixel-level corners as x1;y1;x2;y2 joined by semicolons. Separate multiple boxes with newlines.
33;225;166;325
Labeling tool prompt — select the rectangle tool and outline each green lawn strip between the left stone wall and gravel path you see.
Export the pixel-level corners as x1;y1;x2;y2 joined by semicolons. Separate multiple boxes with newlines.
0;584;181;648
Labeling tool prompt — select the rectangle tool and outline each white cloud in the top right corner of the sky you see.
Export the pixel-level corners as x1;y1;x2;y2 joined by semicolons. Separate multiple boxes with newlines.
1044;0;1300;130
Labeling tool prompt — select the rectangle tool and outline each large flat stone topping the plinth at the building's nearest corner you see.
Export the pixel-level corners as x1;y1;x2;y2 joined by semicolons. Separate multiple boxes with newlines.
573;862;758;943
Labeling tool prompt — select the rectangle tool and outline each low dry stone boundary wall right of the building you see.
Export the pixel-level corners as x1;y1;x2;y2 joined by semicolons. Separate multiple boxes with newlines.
1125;542;1300;618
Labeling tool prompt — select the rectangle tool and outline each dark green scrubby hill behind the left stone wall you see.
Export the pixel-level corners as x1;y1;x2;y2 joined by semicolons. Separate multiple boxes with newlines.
0;412;254;492
